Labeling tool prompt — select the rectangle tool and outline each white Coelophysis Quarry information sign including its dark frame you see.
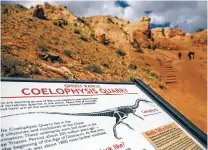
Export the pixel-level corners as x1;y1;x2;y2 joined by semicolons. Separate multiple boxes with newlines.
1;79;206;150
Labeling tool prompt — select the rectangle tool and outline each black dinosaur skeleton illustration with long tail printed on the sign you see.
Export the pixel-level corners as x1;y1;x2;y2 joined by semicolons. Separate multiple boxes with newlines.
1;99;155;140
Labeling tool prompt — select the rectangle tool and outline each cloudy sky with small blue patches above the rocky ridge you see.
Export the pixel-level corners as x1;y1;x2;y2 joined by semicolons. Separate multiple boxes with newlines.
2;0;207;33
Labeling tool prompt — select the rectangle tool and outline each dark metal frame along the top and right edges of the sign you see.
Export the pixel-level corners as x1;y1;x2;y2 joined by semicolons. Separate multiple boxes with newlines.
1;77;207;148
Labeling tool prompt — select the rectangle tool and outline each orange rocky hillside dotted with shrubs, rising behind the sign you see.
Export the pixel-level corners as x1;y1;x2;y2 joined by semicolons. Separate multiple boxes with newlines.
1;3;207;132
